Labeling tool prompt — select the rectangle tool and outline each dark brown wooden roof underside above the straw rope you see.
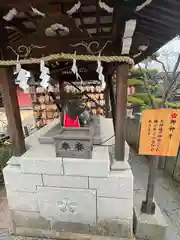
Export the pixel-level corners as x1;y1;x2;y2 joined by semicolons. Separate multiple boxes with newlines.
0;0;180;62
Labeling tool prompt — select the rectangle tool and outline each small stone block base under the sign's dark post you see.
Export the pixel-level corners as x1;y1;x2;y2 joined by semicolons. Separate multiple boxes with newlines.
134;194;168;240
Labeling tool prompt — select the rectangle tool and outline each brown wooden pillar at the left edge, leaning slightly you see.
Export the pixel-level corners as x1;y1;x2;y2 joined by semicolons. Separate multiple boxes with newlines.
0;67;26;156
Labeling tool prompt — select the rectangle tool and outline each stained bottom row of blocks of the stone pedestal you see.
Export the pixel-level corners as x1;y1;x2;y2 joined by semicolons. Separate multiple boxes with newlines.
10;210;133;239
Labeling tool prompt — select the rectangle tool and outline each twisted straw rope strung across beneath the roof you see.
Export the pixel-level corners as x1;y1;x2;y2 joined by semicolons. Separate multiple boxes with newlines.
0;53;134;66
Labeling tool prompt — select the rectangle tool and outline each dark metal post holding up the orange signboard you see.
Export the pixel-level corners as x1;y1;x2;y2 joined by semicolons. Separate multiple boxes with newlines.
141;156;159;214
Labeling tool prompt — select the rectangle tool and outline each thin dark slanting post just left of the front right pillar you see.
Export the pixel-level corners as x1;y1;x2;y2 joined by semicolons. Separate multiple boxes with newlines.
107;75;116;133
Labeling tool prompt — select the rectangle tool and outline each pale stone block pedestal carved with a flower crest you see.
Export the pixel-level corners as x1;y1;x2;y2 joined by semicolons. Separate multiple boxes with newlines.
3;119;133;239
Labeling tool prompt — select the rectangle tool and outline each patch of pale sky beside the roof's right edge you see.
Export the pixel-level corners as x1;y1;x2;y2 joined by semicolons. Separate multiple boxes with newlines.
141;38;180;72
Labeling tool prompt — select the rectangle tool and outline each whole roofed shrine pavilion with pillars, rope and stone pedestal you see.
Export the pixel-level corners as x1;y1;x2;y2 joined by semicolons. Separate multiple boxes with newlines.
0;0;180;239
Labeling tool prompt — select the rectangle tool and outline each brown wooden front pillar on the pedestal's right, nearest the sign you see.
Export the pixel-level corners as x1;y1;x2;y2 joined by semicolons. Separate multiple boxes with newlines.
115;64;129;161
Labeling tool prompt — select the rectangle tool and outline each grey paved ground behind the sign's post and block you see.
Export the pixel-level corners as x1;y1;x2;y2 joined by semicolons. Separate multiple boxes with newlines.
129;153;180;240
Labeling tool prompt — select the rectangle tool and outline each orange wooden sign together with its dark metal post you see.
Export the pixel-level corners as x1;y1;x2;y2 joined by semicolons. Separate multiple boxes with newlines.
139;109;180;214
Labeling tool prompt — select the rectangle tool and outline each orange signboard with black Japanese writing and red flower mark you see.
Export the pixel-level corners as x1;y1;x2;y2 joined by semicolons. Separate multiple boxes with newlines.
139;109;180;156
